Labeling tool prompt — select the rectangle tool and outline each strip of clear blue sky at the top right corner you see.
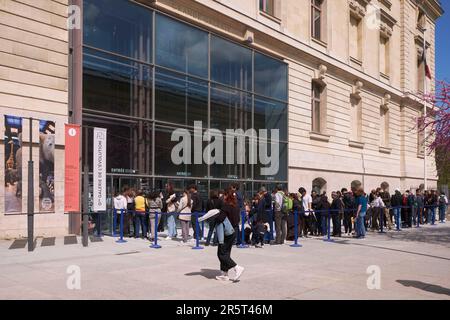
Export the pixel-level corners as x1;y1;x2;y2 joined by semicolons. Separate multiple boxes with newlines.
436;0;450;82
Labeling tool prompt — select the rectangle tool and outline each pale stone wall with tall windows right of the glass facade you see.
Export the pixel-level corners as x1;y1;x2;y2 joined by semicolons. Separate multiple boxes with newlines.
153;0;437;191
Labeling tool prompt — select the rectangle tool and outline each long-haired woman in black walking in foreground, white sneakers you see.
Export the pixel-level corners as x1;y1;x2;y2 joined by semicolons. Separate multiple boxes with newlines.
216;188;245;281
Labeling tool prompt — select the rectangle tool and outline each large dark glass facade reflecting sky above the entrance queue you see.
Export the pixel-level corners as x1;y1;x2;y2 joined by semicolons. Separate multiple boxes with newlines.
83;0;288;194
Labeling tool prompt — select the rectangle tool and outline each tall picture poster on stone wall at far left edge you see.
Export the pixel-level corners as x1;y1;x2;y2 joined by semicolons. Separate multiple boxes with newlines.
4;115;22;213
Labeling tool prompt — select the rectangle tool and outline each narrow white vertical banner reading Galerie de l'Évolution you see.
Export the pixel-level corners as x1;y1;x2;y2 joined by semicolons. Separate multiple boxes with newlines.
93;128;107;212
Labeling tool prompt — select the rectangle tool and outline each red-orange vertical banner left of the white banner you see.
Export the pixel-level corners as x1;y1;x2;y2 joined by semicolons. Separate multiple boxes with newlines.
64;124;81;212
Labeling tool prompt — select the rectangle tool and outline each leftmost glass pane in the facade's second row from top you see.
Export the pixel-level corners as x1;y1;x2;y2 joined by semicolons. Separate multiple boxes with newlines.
83;49;152;118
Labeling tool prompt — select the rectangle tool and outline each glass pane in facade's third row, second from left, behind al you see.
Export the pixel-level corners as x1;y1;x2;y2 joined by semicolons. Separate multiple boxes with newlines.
155;127;208;177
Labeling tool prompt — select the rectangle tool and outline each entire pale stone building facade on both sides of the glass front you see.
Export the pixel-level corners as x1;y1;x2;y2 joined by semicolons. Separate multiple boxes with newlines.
0;0;443;238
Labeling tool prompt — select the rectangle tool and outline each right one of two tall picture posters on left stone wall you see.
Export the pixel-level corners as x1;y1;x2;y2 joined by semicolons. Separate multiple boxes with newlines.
39;120;55;212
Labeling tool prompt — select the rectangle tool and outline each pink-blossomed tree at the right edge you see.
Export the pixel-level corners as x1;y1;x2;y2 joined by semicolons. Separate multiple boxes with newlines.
418;81;450;184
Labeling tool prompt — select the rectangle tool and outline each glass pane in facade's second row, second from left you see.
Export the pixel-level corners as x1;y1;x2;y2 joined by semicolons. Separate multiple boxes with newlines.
155;68;208;126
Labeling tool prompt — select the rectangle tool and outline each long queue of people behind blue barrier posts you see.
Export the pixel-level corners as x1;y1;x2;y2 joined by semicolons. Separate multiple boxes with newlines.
114;183;448;248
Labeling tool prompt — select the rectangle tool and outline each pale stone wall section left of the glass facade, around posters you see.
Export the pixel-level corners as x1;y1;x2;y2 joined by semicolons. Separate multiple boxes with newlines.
0;0;69;238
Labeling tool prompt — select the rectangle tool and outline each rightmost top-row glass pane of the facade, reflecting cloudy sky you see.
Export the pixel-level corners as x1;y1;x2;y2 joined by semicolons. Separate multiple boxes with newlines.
255;53;287;101
